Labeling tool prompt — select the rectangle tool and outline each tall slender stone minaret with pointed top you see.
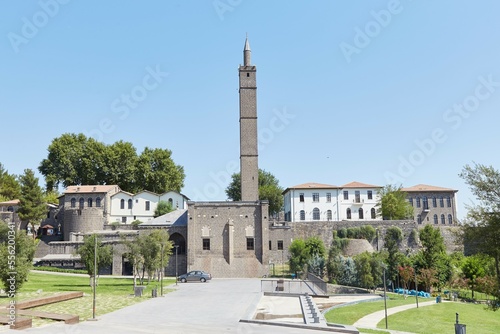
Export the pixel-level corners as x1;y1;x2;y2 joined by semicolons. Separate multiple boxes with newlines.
239;37;259;201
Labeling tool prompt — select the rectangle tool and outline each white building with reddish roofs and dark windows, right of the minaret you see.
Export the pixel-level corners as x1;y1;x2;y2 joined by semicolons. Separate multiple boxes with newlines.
283;182;382;222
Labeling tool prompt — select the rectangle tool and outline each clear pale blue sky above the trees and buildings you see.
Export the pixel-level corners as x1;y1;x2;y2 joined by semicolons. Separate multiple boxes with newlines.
0;0;500;218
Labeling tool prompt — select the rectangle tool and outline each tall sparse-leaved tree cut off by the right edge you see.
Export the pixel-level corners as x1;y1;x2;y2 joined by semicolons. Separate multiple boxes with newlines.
459;163;500;310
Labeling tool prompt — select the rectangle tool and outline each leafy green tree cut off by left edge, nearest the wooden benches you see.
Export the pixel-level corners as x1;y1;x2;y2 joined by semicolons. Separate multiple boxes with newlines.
0;221;36;297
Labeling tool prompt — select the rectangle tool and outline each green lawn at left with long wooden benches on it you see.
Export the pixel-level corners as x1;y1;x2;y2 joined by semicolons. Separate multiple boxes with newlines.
0;272;175;326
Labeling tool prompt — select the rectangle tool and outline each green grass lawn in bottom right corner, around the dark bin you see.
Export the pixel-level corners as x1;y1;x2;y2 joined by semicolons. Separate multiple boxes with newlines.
377;302;500;334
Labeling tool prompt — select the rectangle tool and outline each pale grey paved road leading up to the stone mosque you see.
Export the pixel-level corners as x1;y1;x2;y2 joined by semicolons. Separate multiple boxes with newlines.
19;279;326;334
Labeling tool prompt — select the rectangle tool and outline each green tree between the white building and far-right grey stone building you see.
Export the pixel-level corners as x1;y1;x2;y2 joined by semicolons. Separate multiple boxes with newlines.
376;184;413;220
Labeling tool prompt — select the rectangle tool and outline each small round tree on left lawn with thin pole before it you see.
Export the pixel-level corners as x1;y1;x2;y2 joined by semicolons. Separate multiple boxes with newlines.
77;233;113;284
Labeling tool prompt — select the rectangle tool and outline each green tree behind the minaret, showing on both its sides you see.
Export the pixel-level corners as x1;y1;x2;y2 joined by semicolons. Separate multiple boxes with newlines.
226;169;283;215
